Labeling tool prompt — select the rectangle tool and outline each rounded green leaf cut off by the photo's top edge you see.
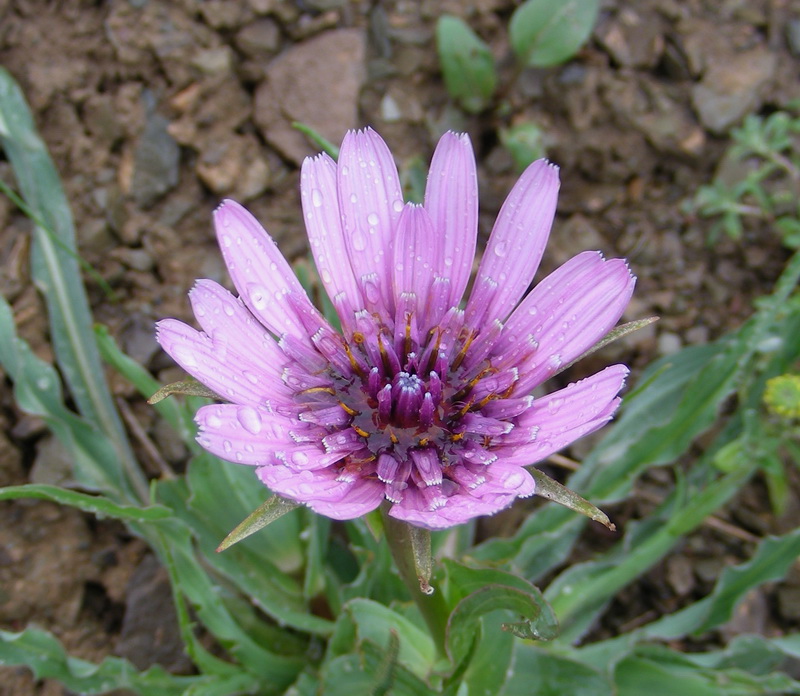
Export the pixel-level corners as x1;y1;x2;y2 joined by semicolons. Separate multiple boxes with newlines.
508;0;600;68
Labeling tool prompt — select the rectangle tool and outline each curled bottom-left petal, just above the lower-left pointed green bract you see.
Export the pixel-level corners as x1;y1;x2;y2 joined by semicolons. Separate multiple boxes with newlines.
256;465;384;520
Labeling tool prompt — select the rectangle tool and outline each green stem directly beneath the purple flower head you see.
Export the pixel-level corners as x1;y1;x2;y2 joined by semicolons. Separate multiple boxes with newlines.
381;506;449;657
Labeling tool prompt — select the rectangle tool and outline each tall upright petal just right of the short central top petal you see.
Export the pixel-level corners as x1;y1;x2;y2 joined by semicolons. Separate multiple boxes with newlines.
425;132;478;307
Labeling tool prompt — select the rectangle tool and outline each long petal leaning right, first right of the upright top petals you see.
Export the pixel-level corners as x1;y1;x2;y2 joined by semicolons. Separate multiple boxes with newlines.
466;160;559;328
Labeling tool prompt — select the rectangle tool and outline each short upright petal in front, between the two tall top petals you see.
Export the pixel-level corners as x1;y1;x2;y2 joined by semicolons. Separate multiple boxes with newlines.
392;203;439;334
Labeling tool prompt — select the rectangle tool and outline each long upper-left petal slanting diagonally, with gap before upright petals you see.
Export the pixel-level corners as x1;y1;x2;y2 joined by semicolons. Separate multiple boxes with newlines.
214;200;325;341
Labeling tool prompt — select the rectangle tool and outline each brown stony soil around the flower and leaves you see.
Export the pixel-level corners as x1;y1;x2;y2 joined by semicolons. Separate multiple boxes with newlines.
0;0;800;696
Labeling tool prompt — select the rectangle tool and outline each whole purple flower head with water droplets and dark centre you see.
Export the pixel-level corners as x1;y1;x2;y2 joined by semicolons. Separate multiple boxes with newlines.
158;129;634;529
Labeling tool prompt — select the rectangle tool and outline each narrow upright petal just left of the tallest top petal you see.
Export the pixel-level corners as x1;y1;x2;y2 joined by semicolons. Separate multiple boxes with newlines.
300;153;364;325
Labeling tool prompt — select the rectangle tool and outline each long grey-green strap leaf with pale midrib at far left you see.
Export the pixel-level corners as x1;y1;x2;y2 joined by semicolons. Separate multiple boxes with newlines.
0;68;148;502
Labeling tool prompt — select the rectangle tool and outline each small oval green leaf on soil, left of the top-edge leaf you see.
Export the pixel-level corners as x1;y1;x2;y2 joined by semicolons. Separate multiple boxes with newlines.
436;15;497;113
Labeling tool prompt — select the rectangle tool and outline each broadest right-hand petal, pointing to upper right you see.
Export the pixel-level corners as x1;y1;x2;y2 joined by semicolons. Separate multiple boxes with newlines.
500;251;636;394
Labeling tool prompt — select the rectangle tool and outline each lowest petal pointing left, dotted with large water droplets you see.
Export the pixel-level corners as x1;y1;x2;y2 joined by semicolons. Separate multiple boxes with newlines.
195;404;332;470
